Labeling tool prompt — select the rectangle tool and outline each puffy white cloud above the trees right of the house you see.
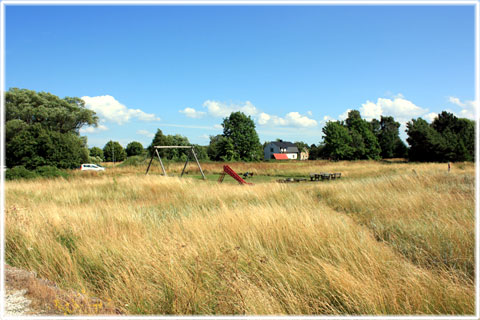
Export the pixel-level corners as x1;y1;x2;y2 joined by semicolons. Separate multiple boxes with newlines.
360;94;428;122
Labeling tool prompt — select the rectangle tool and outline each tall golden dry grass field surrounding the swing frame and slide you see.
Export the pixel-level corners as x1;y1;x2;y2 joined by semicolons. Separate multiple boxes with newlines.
5;161;475;315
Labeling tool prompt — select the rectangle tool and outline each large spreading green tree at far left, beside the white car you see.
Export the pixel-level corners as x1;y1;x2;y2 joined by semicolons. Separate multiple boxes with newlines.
5;88;98;170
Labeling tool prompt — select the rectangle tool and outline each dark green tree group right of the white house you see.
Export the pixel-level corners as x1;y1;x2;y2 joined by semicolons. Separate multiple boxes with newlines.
311;110;475;162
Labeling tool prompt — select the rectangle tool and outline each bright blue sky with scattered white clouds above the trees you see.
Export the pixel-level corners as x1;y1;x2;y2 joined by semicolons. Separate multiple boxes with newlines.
5;5;475;147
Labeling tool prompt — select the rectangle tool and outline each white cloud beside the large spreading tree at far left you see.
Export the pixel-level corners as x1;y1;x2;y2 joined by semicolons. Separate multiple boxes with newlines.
82;95;160;125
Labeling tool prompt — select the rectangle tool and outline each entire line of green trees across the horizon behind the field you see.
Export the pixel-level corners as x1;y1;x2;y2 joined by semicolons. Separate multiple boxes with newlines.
5;88;475;175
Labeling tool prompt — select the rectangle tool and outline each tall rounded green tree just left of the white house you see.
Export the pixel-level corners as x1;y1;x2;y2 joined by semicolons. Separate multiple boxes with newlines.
222;112;263;161
